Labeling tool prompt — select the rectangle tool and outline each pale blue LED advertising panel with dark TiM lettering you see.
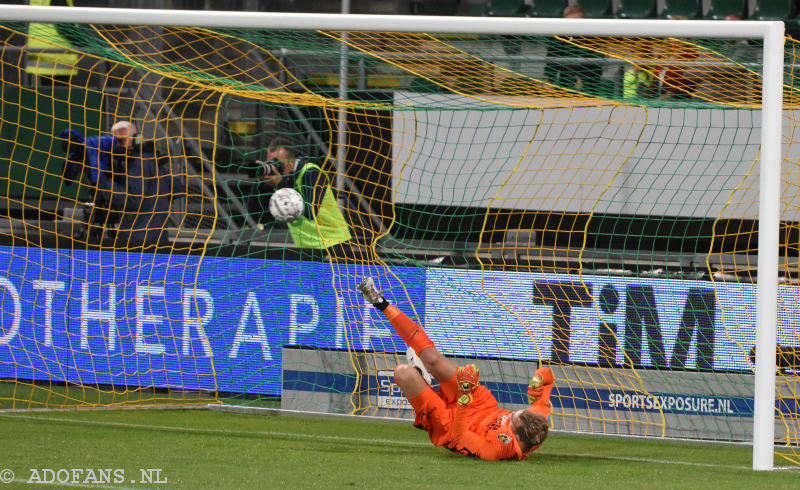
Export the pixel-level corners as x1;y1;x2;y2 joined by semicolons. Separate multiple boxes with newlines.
425;269;800;372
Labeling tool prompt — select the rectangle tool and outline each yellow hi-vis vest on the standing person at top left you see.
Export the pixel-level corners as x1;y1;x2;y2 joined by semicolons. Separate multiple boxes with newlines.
25;0;78;76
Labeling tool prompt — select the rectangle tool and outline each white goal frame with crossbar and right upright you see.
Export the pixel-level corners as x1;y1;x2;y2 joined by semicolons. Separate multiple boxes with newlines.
0;5;784;470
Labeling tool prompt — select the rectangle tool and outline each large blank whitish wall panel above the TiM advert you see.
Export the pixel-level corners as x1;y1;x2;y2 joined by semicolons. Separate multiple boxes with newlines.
392;92;800;218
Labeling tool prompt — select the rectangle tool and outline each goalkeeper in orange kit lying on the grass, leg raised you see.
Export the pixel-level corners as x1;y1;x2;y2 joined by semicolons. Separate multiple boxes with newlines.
358;277;553;461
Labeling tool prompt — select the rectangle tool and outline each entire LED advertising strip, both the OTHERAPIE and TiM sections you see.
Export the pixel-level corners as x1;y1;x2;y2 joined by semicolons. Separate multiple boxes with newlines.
0;247;800;403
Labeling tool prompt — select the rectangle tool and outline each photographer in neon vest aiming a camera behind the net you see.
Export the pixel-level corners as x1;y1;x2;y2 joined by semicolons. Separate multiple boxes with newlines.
247;138;350;253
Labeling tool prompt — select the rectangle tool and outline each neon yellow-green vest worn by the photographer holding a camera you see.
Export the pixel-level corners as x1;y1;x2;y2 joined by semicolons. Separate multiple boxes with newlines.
288;163;351;249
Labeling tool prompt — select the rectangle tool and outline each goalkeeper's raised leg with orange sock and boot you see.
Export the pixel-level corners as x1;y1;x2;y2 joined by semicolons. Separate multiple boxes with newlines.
358;277;458;382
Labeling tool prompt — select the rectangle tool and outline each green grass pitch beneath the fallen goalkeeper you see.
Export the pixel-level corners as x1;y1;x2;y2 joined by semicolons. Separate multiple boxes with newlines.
0;409;800;490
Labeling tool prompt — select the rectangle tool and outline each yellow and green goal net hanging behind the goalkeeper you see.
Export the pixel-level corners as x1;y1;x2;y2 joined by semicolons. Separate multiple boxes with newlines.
0;8;800;463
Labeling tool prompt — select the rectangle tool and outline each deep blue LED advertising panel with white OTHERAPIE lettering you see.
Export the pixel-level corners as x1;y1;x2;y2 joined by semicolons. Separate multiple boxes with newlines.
0;247;425;395
